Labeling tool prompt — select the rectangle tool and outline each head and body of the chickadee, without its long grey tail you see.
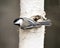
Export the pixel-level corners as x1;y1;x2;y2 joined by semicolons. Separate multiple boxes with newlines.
14;18;36;29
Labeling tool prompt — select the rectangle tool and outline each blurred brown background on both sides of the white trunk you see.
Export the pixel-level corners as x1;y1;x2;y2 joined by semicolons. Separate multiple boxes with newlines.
0;0;60;48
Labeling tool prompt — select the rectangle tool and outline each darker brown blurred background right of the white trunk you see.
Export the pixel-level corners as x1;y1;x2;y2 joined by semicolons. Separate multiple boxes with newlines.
45;0;60;48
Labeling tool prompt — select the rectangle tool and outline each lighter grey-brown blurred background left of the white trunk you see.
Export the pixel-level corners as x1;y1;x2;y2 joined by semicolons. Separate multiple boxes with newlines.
0;0;20;48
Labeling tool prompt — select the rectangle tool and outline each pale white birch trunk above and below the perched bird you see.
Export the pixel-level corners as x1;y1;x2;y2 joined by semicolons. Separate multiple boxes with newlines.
19;0;45;48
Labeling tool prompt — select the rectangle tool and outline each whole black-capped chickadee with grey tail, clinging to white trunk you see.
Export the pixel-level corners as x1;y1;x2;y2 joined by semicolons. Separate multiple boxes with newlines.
14;17;51;29
